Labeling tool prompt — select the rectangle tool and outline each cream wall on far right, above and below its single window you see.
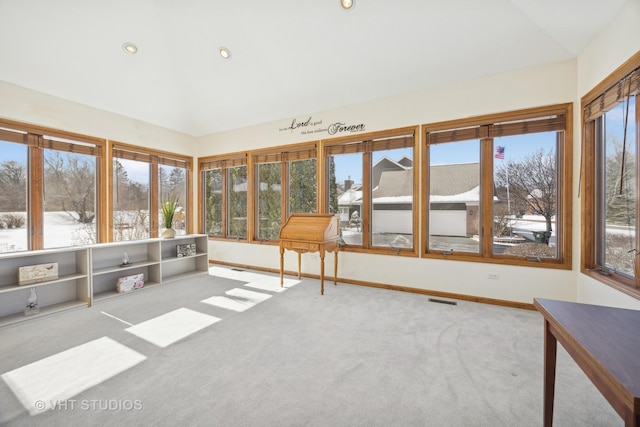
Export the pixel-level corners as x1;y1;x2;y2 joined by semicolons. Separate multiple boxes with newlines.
573;0;640;309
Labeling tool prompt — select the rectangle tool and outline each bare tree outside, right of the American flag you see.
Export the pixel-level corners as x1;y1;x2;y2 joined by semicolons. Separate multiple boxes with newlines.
495;149;557;232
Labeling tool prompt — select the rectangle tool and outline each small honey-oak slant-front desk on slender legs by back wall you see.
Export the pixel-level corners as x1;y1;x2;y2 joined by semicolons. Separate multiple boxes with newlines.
280;214;340;295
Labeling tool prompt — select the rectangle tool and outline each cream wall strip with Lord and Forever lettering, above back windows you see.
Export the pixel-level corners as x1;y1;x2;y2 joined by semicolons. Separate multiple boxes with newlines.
196;61;576;156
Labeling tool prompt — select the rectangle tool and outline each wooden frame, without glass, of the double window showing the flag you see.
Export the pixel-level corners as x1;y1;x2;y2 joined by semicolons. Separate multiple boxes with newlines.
421;103;573;270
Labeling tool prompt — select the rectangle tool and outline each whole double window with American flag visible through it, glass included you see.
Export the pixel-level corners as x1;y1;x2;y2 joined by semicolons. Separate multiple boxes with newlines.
423;104;571;268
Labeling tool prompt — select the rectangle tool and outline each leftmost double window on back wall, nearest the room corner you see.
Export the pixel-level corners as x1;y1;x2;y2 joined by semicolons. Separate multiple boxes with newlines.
198;153;248;240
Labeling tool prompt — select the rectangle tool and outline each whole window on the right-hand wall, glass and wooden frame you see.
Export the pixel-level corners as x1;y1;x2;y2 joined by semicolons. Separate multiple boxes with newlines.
582;54;640;297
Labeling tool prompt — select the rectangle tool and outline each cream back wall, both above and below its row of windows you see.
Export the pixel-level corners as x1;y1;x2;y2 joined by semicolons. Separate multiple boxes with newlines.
198;61;579;303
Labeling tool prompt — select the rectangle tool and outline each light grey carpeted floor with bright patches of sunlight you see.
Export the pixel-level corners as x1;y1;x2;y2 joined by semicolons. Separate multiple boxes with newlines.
0;267;623;427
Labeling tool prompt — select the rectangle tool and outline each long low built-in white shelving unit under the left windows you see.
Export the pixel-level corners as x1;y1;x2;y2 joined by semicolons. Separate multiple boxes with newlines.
0;234;209;326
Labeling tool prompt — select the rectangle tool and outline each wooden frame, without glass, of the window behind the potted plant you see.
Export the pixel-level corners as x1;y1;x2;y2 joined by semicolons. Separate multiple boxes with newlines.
106;141;195;242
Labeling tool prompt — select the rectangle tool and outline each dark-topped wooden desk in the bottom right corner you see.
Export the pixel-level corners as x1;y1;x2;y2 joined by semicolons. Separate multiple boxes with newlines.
533;298;640;427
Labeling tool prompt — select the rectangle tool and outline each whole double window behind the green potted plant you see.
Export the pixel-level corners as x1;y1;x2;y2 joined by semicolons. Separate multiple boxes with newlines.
111;142;192;241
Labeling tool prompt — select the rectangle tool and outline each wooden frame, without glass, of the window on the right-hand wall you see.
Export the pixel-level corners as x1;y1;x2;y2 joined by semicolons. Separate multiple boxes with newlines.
580;51;640;299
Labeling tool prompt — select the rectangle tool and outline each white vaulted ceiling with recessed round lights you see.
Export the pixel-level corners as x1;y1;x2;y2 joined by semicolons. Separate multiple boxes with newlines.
0;0;635;136
